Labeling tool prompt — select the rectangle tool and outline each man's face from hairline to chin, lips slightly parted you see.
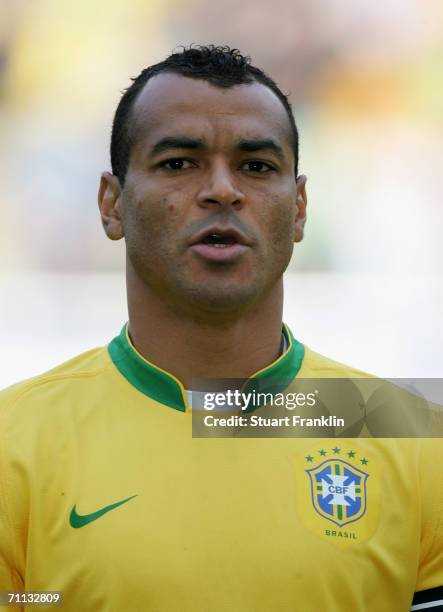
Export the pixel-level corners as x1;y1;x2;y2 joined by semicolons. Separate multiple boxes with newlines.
102;73;306;311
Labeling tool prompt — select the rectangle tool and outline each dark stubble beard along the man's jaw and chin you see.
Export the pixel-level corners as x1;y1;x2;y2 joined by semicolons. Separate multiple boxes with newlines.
125;200;293;323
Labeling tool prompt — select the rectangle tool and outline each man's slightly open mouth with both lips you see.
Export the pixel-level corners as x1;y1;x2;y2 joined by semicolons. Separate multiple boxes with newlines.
190;227;250;262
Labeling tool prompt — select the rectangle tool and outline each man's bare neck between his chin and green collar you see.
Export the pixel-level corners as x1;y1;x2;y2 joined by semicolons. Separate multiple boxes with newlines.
127;271;283;389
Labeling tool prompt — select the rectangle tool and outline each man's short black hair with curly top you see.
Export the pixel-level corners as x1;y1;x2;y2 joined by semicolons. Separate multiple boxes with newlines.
111;45;298;185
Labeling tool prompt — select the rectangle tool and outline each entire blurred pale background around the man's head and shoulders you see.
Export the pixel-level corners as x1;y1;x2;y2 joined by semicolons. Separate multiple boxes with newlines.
0;0;443;387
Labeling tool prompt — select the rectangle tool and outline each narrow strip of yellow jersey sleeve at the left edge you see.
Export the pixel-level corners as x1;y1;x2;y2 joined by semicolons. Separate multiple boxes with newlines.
0;384;24;611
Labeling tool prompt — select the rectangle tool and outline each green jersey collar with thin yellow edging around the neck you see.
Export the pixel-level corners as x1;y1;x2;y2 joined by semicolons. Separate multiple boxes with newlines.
108;323;305;412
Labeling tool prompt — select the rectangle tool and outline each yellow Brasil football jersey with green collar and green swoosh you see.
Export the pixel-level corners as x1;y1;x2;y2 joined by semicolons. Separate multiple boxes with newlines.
0;326;443;612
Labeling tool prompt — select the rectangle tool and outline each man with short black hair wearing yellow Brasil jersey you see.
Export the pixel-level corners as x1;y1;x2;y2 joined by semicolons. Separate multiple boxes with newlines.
0;47;443;612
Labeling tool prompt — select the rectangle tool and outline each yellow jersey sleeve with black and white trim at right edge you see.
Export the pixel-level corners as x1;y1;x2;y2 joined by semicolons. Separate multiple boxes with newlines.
411;438;443;612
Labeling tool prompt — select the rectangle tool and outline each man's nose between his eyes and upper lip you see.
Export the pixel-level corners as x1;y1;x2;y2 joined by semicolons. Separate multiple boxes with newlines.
197;161;245;208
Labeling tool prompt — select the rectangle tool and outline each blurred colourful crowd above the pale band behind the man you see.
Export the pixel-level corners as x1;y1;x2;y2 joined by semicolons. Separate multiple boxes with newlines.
0;0;443;274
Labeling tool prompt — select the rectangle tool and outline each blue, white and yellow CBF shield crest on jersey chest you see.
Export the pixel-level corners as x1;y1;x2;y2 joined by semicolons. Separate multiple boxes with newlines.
306;449;369;527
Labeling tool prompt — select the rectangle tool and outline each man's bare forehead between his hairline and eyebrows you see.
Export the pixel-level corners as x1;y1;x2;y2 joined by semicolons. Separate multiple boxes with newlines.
131;73;292;149
